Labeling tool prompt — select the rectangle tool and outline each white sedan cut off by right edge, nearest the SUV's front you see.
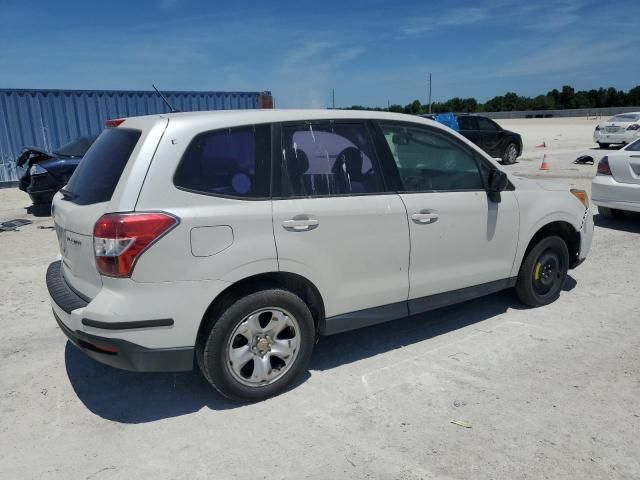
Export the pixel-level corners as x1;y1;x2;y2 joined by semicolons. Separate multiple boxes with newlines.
591;139;640;218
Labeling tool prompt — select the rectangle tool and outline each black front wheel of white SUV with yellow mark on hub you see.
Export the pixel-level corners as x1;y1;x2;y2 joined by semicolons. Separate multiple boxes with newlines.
516;236;569;307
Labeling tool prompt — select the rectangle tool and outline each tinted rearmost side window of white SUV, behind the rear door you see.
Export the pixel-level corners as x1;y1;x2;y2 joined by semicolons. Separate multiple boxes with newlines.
174;125;271;198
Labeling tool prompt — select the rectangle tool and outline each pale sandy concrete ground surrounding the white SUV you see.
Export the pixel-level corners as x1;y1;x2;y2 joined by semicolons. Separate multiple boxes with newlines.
0;119;640;480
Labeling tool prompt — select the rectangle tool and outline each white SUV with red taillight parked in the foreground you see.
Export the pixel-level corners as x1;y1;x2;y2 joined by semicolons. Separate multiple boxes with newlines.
47;110;593;401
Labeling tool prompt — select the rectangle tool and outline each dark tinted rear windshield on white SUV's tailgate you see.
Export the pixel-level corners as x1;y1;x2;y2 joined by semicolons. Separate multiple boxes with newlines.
64;128;142;205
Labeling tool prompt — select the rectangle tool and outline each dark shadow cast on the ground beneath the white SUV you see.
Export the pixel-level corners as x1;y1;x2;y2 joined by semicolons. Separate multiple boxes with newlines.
64;276;576;424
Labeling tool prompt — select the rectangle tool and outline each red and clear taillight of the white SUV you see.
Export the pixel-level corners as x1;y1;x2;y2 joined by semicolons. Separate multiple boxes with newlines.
93;213;178;277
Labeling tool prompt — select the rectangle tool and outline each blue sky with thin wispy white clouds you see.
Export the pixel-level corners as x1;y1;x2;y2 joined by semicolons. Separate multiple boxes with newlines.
0;0;640;108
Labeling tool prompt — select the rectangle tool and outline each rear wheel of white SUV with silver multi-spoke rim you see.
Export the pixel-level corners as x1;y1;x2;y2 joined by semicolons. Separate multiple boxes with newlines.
196;289;315;402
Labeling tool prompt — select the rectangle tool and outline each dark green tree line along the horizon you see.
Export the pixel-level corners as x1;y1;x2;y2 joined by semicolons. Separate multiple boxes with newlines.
350;85;640;115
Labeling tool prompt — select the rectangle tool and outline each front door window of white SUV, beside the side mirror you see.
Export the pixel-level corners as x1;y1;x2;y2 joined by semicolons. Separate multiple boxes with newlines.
381;124;484;192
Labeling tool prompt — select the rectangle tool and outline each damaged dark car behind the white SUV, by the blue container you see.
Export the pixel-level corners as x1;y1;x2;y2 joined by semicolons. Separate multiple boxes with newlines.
16;135;97;205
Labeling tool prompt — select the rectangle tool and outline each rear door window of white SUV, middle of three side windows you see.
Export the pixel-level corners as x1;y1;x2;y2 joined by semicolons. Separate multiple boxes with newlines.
281;123;383;197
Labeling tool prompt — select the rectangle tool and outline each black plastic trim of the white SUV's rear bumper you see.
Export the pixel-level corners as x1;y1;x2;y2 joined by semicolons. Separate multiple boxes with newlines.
47;261;194;372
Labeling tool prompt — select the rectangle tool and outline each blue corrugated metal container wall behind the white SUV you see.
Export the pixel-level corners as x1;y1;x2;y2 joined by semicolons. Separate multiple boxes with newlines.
0;89;270;183
